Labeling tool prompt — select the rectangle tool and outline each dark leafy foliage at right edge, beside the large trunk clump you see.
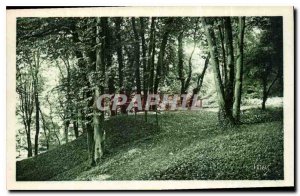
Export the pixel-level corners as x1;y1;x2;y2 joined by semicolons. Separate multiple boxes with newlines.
243;17;283;98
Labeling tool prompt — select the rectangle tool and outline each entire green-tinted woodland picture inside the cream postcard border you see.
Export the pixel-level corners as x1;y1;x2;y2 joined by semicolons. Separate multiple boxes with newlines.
15;16;284;181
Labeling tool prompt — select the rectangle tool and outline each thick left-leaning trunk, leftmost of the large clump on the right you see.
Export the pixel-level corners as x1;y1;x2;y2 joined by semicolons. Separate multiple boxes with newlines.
201;18;233;125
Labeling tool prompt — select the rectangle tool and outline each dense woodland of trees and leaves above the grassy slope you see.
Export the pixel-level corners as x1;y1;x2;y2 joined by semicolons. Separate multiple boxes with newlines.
16;17;283;178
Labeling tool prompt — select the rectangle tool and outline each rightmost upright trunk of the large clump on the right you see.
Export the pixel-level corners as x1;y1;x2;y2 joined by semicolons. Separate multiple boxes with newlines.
233;17;245;122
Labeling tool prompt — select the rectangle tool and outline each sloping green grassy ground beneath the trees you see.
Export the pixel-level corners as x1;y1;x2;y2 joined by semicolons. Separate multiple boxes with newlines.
17;108;284;181
